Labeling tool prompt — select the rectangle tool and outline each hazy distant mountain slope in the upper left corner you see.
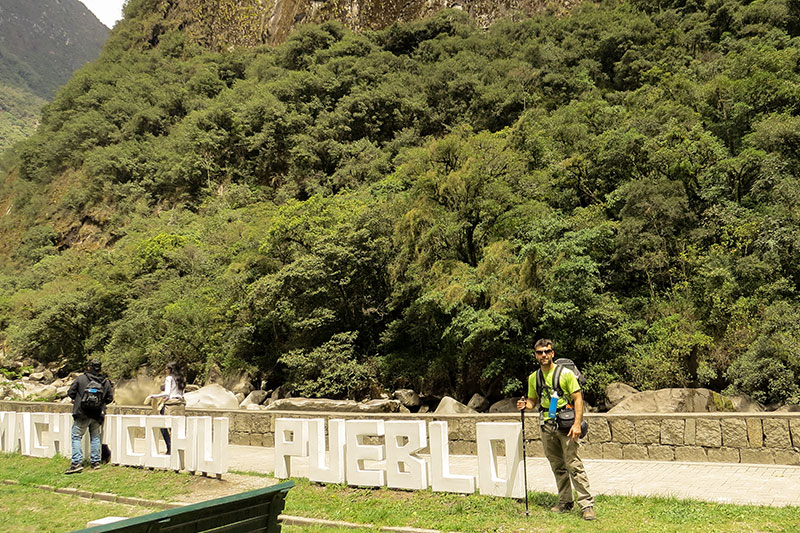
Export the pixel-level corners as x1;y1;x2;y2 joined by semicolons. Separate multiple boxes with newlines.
0;0;108;153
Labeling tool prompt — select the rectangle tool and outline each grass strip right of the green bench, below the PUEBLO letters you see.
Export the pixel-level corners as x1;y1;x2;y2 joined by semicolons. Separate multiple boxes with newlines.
284;479;800;533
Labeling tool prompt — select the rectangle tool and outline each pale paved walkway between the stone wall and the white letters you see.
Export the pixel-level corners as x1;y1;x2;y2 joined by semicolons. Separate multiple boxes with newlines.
229;445;800;507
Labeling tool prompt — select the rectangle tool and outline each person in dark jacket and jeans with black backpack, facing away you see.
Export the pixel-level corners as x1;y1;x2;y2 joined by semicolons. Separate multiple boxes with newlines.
64;361;114;474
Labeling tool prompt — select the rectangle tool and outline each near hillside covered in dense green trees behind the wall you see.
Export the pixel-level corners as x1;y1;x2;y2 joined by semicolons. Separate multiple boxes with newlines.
0;0;800;403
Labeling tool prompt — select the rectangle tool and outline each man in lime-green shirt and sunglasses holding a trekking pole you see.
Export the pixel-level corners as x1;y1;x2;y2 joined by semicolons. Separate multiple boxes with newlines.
517;339;596;520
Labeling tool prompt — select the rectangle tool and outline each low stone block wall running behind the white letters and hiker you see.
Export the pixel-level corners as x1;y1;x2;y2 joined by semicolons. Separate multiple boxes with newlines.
0;401;800;465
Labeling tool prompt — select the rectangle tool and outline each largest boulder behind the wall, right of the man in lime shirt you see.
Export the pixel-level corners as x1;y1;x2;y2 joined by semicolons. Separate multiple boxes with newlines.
609;388;755;414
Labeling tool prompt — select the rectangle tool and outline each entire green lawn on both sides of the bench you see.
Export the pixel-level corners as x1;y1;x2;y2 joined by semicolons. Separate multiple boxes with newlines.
0;454;800;533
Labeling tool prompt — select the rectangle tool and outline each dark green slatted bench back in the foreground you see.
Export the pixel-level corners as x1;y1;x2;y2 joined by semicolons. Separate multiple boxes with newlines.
74;481;294;533
